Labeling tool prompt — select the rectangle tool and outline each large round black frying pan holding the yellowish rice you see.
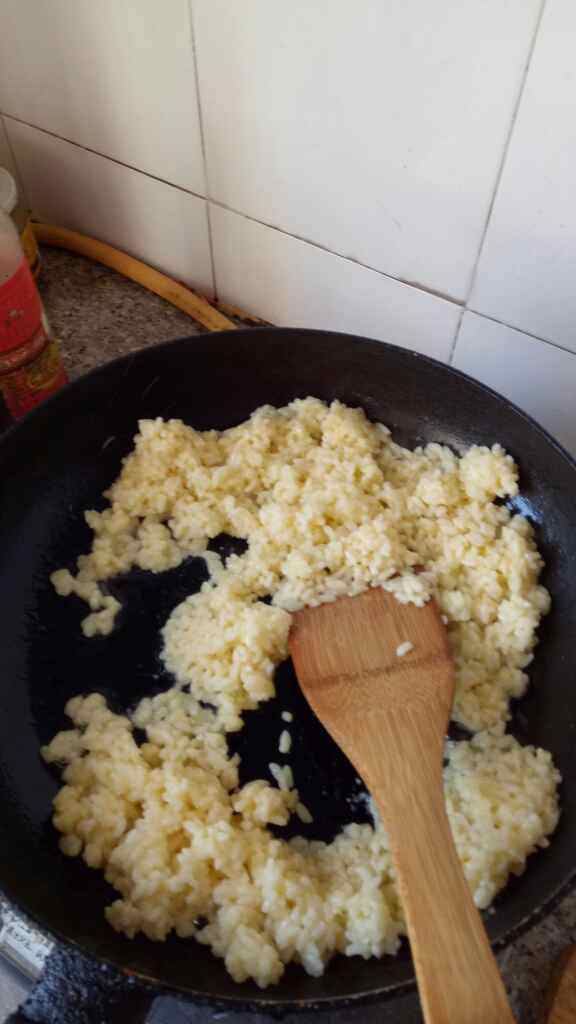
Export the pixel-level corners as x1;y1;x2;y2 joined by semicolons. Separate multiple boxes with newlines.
0;329;576;1024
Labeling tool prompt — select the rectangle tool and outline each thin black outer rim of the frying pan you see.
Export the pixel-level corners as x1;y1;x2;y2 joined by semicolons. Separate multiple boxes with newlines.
0;326;576;1013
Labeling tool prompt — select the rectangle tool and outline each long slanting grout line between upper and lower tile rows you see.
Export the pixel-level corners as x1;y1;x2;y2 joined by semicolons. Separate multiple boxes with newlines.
0;111;464;307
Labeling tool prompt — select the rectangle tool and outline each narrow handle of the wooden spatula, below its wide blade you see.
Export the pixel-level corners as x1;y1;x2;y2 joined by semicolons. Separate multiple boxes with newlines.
366;711;513;1024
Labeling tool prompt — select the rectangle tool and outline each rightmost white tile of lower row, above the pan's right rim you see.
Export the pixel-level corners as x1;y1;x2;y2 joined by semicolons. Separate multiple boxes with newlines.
453;312;576;455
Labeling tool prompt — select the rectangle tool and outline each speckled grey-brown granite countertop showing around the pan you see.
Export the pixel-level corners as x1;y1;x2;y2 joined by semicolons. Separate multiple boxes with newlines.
6;250;576;1024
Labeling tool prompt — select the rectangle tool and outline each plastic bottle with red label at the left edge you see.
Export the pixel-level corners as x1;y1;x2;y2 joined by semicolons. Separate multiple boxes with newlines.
0;210;68;429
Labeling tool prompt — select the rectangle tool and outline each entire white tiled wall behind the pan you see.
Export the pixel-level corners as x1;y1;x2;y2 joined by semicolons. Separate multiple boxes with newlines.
0;0;576;451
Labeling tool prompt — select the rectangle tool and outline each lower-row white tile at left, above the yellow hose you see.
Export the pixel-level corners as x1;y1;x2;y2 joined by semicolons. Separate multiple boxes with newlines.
5;118;212;295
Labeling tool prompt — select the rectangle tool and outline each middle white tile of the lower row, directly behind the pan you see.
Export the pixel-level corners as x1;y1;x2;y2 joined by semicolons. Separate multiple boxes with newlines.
210;208;460;359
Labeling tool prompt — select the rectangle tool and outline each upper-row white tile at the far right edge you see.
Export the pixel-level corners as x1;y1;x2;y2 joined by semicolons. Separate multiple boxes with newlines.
470;0;576;351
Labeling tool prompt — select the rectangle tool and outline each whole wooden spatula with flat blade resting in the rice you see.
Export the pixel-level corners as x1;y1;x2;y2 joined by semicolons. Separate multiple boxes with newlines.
290;589;513;1024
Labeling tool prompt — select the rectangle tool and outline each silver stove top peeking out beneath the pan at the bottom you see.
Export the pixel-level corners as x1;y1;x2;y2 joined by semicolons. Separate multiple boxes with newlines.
0;900;422;1024
